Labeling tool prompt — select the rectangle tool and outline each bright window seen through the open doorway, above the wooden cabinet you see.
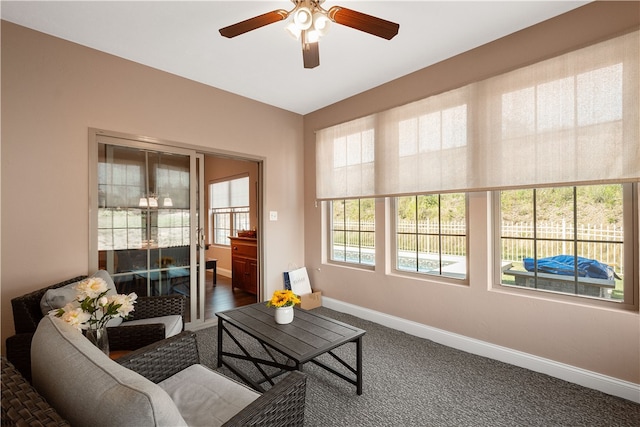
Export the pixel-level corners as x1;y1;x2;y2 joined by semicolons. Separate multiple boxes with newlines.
209;176;250;246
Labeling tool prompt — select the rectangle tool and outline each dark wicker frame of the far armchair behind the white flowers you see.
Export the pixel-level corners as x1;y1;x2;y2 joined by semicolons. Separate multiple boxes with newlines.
6;276;186;381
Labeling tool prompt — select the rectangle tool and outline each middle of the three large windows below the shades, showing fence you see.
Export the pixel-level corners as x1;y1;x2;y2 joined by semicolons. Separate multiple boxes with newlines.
395;193;467;279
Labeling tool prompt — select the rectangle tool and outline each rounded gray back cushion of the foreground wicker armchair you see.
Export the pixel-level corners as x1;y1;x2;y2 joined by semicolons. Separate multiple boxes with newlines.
31;316;186;426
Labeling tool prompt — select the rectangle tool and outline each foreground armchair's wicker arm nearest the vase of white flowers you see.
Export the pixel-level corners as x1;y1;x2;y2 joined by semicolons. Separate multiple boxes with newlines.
116;332;200;384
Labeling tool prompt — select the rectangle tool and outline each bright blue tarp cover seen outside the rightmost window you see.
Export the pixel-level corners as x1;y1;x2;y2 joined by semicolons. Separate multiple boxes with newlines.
522;255;617;280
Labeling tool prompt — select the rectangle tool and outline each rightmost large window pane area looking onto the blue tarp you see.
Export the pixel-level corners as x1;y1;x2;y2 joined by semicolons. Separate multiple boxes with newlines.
498;184;637;302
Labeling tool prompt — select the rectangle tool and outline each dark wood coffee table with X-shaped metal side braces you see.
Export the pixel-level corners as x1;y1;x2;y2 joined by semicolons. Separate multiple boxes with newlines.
216;303;366;395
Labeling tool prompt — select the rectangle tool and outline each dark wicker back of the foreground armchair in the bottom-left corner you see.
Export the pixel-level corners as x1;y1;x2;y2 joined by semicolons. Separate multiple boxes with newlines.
2;356;70;427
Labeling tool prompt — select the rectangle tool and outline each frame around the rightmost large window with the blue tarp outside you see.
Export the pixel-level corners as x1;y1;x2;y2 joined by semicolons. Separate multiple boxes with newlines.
490;182;640;311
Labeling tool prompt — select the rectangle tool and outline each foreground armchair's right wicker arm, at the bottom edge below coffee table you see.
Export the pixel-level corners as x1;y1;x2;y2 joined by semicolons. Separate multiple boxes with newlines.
223;371;307;427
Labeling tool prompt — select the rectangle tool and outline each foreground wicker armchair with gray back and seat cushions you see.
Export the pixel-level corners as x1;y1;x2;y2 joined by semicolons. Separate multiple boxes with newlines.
2;316;306;427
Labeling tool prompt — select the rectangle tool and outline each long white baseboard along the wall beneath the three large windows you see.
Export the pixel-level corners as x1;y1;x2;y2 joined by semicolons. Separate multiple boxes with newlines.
322;295;640;403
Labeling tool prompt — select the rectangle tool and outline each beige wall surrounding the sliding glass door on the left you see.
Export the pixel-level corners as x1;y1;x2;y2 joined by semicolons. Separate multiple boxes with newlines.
1;21;304;348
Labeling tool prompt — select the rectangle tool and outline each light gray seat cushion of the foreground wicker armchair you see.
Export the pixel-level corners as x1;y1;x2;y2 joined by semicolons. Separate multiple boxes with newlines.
159;365;260;426
